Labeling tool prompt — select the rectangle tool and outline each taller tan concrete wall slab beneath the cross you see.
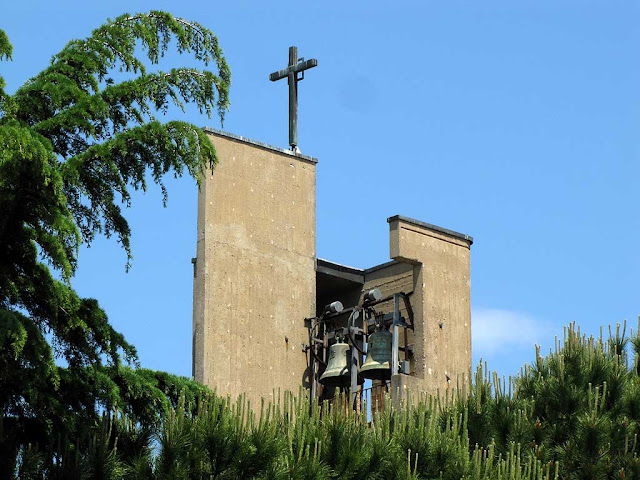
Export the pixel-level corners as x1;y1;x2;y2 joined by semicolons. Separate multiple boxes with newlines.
193;131;316;405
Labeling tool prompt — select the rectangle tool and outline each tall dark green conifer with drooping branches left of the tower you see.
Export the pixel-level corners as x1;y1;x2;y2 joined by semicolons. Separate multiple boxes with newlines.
0;11;230;472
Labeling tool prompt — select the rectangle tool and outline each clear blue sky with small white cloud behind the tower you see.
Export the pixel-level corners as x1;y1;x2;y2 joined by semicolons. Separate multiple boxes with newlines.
0;0;640;376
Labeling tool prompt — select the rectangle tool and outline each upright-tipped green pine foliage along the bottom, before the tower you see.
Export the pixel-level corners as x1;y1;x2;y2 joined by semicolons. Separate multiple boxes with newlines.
6;320;640;480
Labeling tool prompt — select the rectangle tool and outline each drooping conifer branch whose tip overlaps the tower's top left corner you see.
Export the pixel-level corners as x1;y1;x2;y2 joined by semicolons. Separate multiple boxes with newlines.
62;121;216;260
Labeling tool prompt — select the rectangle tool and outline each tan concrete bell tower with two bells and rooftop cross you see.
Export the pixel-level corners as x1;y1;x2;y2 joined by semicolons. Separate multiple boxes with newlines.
193;47;473;409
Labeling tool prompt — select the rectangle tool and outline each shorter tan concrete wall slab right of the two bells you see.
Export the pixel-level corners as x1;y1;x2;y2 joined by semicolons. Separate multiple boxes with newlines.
389;216;473;394
